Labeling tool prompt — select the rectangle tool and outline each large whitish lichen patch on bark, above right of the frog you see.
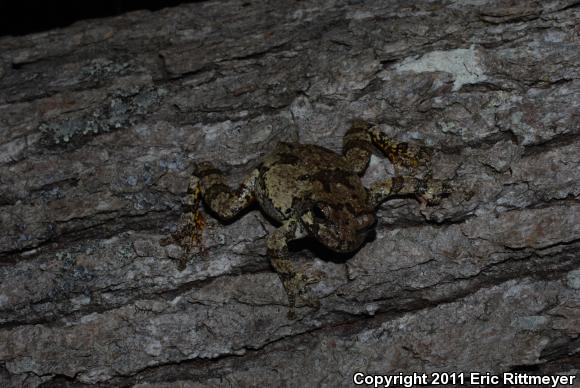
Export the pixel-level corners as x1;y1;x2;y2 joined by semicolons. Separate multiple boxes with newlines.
395;46;487;91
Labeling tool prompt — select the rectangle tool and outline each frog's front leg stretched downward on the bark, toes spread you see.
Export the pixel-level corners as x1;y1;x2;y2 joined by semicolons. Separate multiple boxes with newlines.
267;219;320;319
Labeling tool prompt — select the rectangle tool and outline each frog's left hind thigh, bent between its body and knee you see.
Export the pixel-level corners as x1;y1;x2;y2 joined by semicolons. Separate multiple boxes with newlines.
195;162;258;221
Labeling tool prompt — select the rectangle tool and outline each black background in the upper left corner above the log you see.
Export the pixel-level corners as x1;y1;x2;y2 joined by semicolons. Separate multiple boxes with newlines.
0;0;206;36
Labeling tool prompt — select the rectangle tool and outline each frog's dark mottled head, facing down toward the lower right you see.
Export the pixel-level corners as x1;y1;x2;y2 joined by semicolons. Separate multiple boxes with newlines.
302;203;375;253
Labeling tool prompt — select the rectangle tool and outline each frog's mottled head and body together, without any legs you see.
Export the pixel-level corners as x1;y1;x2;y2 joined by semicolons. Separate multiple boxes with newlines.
255;143;374;252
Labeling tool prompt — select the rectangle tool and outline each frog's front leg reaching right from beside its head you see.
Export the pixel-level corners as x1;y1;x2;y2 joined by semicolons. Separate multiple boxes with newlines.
369;176;451;207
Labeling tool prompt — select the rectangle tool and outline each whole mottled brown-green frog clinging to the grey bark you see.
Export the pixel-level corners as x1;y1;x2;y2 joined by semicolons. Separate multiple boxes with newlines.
161;119;452;319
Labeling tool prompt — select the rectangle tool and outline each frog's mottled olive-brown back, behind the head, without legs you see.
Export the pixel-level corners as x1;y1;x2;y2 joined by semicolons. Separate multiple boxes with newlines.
257;143;366;222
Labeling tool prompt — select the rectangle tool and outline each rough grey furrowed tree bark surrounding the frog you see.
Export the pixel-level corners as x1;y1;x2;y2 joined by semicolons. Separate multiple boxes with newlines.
0;0;580;387
